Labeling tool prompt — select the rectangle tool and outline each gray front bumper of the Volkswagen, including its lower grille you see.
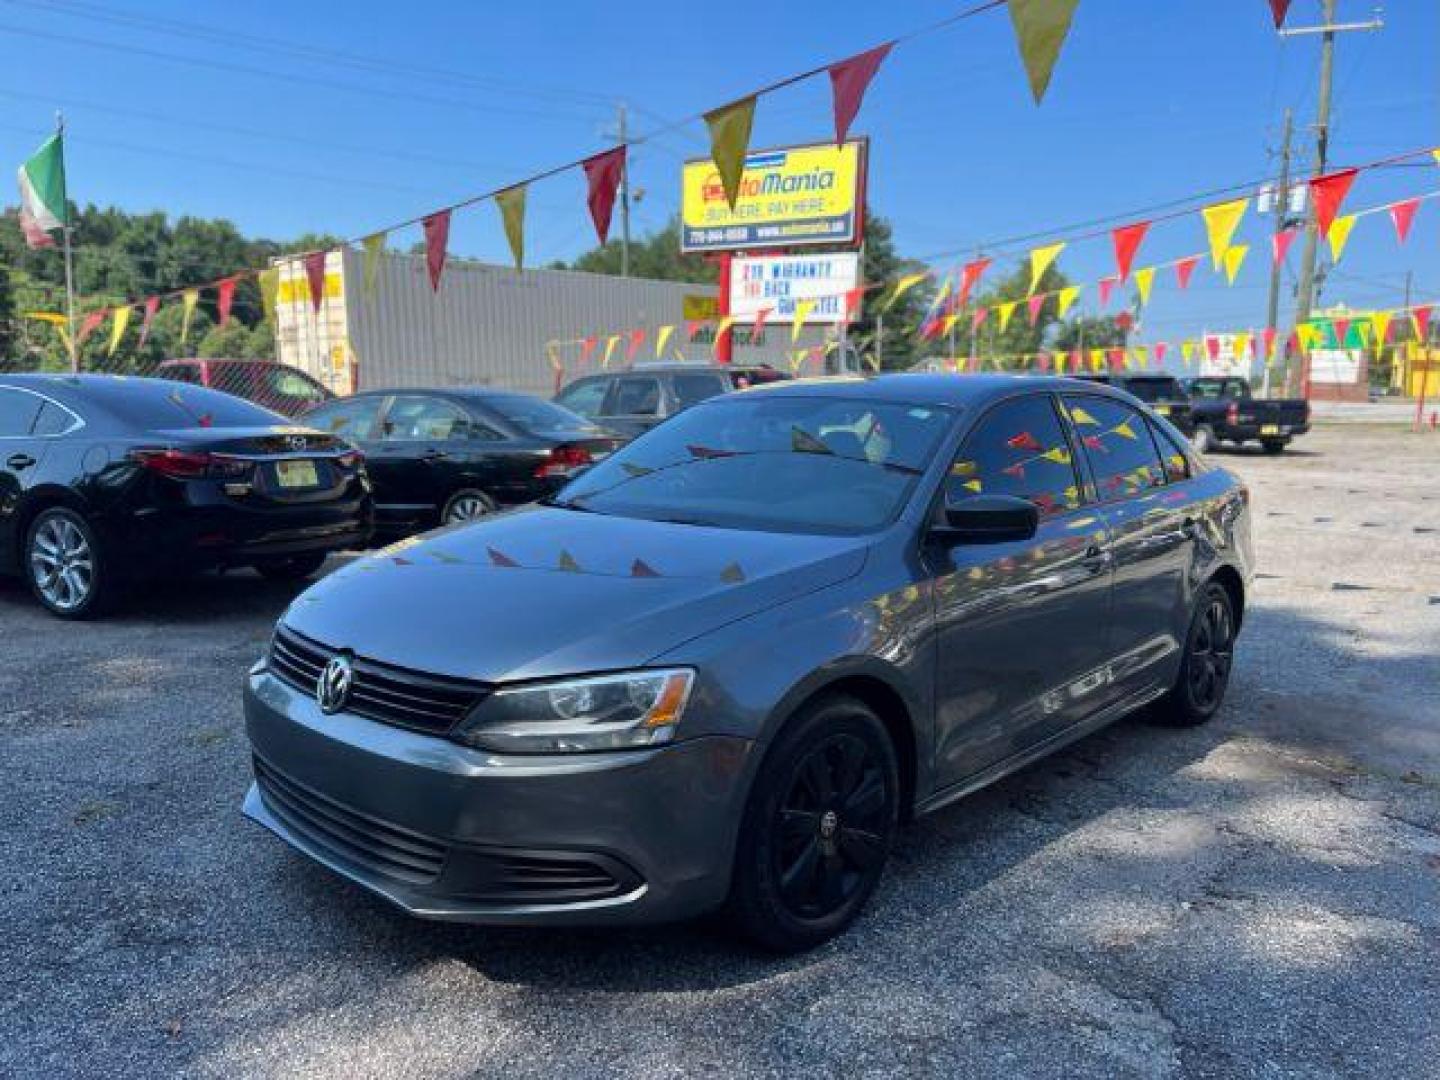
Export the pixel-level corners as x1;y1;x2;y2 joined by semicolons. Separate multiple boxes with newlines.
243;671;753;924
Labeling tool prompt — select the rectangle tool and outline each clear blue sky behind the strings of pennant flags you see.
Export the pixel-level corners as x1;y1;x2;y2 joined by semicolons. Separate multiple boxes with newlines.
0;0;1440;347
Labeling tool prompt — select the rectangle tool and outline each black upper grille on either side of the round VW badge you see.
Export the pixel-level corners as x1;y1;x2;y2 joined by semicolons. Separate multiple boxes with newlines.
271;625;490;734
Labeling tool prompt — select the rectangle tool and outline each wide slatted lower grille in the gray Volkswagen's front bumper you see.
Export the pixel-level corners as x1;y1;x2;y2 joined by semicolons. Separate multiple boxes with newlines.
255;757;448;884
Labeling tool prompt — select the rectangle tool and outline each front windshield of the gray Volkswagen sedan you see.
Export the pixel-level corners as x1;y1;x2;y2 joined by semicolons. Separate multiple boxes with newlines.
553;395;955;536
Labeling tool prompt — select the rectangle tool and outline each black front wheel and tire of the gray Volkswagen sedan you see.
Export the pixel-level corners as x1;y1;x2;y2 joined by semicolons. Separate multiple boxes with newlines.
726;696;900;953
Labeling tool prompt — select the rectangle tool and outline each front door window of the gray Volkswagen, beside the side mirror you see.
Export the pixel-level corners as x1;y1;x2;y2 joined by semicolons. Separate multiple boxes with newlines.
946;393;1080;517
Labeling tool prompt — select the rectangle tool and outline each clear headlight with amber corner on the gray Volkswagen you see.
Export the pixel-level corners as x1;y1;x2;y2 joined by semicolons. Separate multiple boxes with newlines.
456;668;696;753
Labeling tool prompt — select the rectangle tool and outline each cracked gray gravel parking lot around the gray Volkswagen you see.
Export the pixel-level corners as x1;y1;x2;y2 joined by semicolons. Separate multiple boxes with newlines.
0;425;1440;1077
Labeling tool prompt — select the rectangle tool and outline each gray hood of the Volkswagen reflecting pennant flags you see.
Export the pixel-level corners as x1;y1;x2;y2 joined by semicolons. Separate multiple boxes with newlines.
284;507;867;683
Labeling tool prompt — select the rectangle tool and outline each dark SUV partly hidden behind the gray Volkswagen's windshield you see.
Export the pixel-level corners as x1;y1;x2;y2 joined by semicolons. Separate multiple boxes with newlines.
554;364;754;438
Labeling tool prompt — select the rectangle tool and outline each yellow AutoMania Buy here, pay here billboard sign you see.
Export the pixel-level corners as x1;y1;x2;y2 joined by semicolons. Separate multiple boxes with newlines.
680;140;865;252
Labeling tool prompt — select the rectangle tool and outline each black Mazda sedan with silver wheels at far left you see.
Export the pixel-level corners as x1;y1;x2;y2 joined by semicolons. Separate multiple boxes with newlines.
0;374;372;618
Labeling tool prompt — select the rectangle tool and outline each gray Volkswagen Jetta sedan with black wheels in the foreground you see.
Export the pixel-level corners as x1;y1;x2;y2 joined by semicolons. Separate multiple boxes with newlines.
245;374;1251;950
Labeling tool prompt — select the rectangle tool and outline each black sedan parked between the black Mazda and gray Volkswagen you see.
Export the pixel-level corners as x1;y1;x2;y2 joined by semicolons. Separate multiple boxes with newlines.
305;390;621;536
